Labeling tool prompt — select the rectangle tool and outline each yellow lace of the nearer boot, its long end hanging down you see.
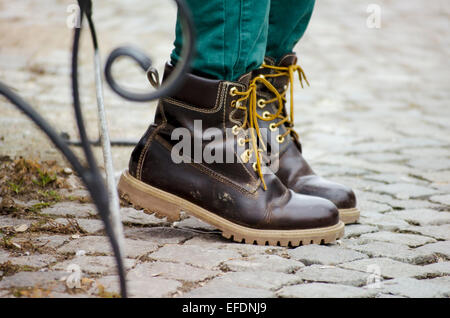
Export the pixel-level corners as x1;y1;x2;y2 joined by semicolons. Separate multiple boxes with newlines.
230;75;283;190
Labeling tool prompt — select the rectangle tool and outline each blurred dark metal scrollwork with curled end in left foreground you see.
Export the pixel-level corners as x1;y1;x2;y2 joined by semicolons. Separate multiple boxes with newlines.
0;0;195;298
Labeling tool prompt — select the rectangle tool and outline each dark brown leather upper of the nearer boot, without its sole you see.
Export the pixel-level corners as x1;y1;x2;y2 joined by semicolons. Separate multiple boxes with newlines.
129;65;339;230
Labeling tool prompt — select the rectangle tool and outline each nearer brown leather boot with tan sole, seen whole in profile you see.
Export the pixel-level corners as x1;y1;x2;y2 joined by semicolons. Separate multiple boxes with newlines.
119;65;344;246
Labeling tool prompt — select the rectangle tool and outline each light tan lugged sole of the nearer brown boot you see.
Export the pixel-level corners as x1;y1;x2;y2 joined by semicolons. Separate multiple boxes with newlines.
118;171;344;246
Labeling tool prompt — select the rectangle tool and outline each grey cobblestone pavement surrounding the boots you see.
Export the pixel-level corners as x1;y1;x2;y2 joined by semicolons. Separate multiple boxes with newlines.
0;0;450;297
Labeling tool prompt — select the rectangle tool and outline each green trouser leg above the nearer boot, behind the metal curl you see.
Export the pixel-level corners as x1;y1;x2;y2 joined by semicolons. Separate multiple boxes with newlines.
171;0;270;81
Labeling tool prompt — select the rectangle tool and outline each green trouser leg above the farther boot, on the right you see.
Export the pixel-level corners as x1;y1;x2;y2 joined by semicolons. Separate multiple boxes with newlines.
266;0;315;61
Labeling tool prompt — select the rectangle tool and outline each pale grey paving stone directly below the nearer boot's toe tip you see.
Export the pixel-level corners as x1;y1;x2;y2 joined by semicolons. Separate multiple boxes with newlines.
288;245;367;265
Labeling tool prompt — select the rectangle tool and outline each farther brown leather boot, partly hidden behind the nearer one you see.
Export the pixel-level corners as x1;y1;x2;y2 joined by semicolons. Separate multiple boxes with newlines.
254;53;359;224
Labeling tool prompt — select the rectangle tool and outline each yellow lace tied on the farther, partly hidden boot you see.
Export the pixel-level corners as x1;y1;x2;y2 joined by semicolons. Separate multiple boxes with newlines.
258;63;309;143
